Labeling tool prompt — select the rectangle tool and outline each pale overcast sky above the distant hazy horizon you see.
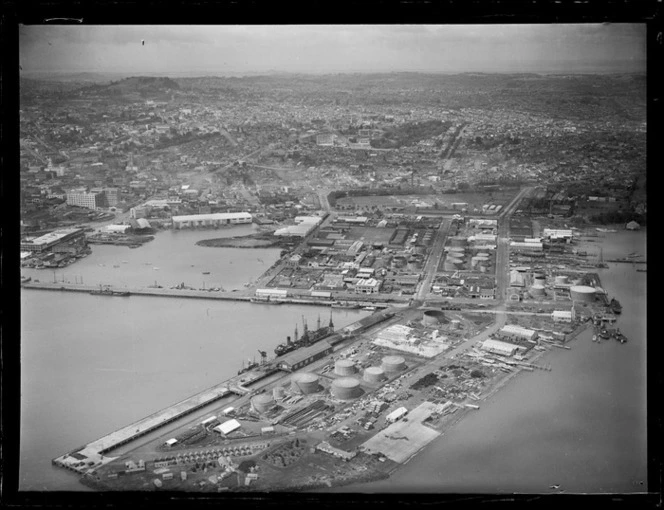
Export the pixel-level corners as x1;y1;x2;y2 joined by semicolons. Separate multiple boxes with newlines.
19;24;646;75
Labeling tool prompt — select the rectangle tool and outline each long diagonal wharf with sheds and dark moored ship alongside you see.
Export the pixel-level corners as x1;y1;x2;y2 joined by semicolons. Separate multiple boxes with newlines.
51;312;394;476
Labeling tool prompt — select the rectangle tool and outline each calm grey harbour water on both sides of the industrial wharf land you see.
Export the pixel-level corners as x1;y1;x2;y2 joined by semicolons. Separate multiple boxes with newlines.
20;227;647;493
